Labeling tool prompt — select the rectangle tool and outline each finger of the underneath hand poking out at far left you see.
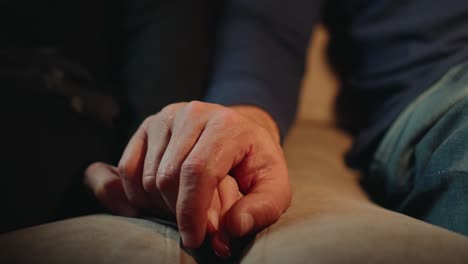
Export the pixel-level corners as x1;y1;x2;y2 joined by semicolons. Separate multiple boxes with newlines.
84;163;137;217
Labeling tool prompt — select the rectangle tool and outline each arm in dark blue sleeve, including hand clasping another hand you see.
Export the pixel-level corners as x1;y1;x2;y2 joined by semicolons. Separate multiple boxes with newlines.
89;0;319;256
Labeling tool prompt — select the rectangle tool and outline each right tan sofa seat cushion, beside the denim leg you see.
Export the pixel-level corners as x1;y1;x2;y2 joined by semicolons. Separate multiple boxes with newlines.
242;122;468;263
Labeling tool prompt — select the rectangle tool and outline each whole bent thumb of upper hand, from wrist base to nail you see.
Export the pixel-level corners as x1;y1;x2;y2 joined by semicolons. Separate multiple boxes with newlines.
214;115;291;237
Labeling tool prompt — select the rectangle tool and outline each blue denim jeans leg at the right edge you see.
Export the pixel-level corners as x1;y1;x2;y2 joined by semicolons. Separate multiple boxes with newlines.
365;62;468;235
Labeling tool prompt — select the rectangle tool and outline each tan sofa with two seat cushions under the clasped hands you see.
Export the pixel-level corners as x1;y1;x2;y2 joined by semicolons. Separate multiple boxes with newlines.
0;27;466;264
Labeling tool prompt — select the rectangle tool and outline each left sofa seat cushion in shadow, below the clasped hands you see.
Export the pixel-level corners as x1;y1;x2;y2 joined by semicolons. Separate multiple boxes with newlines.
0;215;195;263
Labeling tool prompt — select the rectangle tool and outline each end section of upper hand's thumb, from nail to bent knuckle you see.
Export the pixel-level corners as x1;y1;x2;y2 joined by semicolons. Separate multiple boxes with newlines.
224;189;291;238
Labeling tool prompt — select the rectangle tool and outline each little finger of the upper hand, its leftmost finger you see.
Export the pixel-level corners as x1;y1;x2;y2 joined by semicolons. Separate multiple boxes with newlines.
118;117;152;208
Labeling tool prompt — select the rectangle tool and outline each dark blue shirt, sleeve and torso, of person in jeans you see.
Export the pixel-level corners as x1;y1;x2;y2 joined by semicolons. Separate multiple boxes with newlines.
206;0;468;168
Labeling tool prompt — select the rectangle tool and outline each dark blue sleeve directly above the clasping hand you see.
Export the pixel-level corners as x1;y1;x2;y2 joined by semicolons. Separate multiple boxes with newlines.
205;0;321;140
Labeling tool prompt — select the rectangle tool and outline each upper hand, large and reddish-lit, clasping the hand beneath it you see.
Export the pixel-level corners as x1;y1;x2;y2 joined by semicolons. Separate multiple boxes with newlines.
84;102;291;254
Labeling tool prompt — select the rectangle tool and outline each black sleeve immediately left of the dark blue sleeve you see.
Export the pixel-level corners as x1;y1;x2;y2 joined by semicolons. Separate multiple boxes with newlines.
115;0;220;130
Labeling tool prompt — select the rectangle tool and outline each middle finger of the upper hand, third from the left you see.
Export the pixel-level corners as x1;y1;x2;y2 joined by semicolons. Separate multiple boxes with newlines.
156;102;206;213
